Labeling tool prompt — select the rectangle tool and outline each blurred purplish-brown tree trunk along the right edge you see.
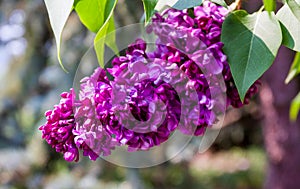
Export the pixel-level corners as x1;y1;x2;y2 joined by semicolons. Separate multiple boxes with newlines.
260;47;300;189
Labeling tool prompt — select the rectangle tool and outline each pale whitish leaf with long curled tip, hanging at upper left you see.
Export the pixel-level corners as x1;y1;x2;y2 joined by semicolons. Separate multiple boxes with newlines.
44;0;74;71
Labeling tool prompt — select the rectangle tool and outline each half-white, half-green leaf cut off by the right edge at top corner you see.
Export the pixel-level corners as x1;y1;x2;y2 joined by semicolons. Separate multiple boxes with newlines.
276;1;300;51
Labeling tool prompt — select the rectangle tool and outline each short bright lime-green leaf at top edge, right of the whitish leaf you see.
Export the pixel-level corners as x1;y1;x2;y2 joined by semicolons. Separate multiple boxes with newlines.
73;0;104;33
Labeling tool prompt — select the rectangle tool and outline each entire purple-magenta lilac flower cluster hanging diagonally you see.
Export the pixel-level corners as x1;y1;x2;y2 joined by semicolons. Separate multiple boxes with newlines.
40;1;258;161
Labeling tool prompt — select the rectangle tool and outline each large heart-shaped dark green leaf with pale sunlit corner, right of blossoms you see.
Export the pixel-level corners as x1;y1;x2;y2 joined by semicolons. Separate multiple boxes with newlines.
221;11;282;101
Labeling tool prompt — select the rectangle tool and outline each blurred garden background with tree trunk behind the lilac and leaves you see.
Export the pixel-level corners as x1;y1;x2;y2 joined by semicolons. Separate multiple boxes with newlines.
0;0;300;189
